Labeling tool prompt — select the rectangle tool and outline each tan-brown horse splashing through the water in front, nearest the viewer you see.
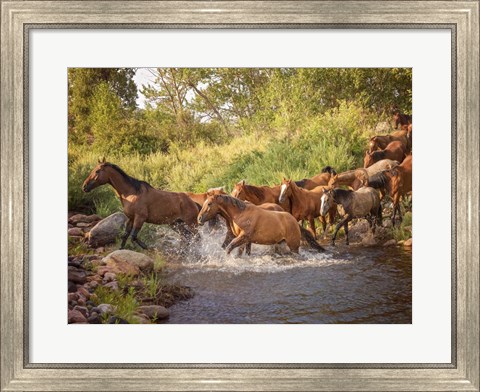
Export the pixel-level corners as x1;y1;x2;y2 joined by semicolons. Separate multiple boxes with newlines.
198;195;324;254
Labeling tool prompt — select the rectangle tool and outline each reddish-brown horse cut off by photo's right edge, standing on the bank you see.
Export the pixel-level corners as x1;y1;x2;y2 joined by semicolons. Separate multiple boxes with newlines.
384;154;412;225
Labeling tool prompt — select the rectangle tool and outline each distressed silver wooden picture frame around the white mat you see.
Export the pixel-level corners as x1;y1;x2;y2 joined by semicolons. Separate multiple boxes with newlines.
0;0;480;391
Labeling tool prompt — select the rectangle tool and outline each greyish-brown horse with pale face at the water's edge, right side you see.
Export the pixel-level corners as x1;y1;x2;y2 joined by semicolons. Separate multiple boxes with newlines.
320;187;382;245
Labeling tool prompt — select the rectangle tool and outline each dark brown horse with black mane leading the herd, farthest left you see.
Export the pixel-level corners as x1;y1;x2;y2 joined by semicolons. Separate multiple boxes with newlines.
82;159;198;249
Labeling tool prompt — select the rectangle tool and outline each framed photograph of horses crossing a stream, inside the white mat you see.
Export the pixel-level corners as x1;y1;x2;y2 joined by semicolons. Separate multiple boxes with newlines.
65;67;413;327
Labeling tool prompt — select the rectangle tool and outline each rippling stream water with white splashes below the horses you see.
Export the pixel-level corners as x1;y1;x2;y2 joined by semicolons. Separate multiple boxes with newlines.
156;225;412;324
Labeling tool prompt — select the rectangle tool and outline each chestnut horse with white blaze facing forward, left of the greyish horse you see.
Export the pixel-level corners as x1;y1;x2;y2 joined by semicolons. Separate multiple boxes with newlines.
279;178;337;238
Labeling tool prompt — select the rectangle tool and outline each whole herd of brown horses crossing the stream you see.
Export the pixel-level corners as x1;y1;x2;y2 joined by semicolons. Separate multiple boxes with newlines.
82;115;412;254
